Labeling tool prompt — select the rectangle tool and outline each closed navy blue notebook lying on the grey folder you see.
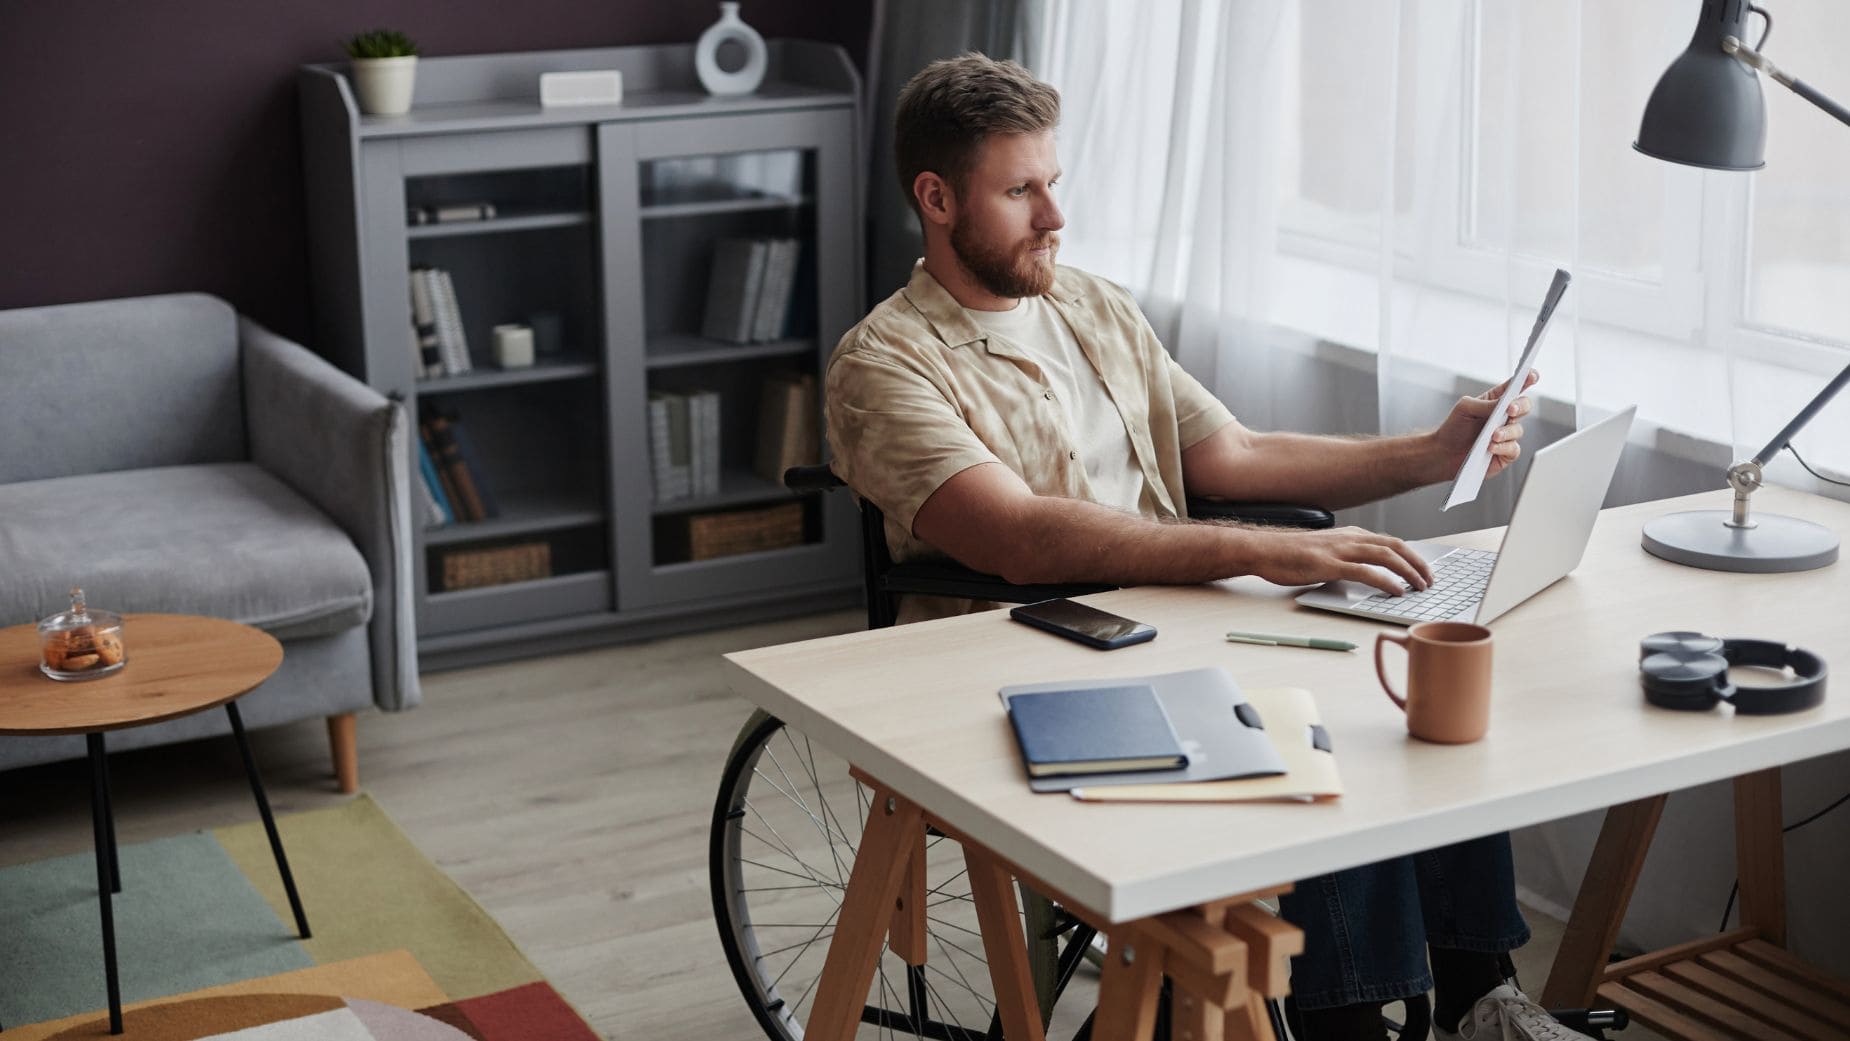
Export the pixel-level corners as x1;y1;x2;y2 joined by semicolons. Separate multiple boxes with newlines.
1008;684;1188;777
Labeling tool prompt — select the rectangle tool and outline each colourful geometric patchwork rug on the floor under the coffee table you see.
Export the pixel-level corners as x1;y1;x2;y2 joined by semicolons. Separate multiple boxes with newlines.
0;795;598;1041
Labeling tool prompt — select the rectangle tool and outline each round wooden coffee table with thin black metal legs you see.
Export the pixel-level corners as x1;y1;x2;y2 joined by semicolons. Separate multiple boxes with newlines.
0;614;309;1034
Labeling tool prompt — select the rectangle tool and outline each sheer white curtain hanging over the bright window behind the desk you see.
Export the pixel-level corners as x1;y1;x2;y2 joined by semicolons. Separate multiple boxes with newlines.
1023;0;1850;971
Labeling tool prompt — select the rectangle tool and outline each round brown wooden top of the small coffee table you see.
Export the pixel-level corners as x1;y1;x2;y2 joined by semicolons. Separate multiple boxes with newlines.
0;614;283;736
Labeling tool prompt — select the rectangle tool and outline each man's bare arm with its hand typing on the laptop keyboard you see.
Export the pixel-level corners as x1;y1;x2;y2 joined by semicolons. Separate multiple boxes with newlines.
912;462;1432;594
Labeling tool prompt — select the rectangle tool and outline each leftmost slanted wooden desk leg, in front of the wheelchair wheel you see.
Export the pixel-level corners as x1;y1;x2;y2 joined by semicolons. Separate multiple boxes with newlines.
803;786;925;1041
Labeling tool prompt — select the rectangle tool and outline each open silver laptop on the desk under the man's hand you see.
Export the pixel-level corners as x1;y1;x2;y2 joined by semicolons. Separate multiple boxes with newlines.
1297;405;1637;625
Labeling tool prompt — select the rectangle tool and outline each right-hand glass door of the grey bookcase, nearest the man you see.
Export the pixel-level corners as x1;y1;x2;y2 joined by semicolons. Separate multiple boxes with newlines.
598;111;860;610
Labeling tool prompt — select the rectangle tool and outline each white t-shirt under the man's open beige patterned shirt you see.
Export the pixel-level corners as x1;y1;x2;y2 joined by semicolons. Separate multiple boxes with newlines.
964;296;1145;512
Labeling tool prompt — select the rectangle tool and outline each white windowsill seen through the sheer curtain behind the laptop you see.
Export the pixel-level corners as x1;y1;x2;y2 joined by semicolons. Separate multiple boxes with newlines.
1267;255;1850;490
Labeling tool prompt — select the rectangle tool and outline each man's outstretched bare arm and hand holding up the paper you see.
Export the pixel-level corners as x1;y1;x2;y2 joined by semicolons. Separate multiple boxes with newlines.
1182;372;1537;510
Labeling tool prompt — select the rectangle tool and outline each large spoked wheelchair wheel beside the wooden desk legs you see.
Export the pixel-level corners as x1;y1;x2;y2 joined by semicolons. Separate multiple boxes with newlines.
709;712;1090;1041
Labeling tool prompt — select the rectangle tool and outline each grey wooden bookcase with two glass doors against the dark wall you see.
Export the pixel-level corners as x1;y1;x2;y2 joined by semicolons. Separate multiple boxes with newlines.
298;41;864;667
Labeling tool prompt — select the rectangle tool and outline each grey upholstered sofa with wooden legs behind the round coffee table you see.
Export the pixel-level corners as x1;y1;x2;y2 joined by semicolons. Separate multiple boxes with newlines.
0;294;418;790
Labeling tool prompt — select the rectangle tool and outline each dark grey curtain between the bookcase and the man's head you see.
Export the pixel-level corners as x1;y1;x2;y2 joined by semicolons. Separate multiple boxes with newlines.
862;0;1036;305
